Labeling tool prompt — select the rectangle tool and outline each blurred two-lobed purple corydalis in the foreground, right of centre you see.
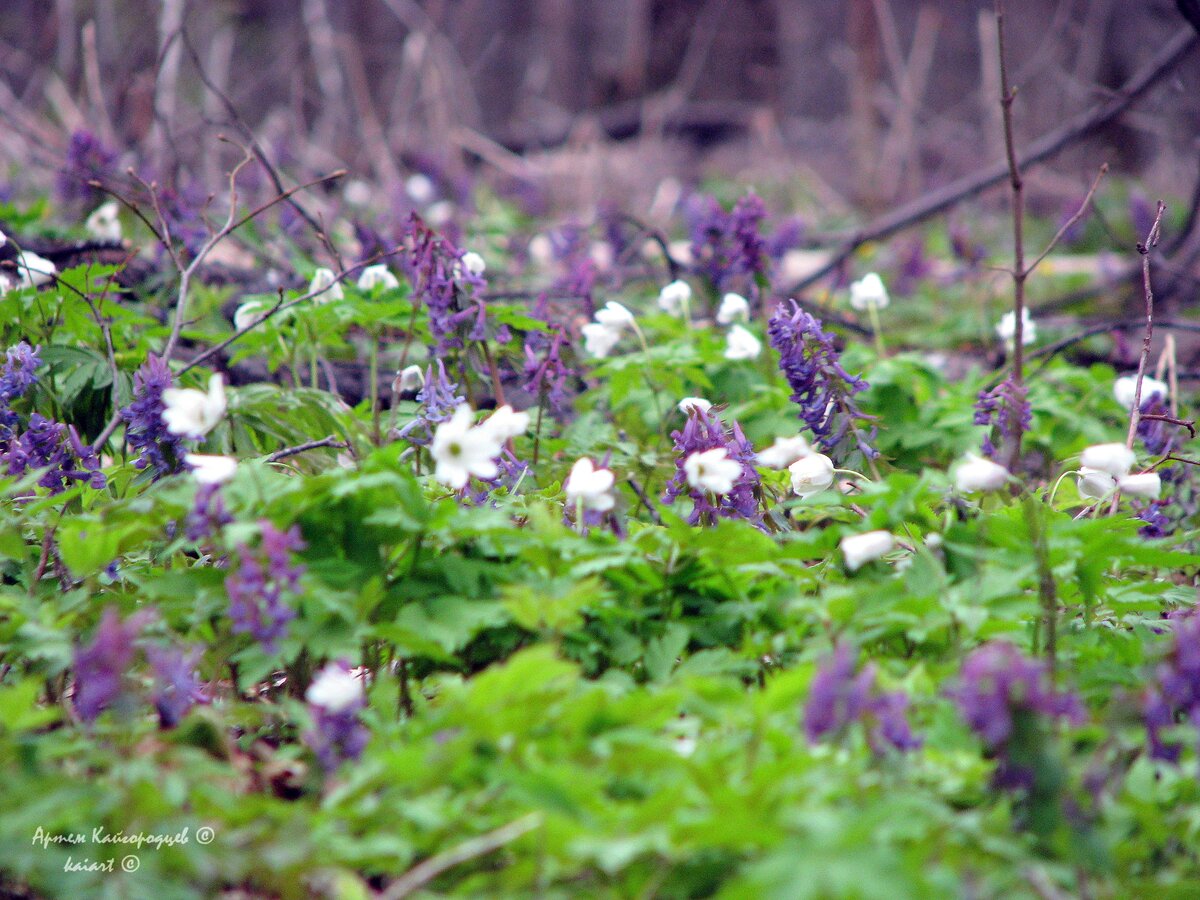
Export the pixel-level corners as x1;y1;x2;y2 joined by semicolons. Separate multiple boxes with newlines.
804;644;920;751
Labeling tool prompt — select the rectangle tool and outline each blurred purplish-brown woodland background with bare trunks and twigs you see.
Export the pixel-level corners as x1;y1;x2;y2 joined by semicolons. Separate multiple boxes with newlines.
0;0;1200;224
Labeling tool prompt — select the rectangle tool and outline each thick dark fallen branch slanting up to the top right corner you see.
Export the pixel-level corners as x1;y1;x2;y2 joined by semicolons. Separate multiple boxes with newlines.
790;30;1200;294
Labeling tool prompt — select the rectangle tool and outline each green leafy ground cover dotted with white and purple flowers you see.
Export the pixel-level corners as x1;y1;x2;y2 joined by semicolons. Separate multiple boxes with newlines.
0;162;1200;899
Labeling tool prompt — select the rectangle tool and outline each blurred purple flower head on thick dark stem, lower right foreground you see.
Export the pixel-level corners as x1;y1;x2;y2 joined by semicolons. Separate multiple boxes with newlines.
948;641;1084;788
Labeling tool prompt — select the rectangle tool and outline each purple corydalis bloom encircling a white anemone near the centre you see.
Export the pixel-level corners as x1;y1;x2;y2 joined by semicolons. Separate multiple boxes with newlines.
662;404;762;527
